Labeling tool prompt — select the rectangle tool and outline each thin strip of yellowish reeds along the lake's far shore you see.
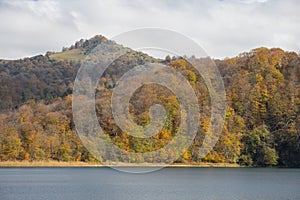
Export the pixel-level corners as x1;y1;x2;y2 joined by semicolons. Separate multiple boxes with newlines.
0;161;244;168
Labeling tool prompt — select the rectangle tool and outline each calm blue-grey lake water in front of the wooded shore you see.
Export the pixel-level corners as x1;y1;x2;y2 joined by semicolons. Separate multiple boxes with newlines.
0;168;300;200
